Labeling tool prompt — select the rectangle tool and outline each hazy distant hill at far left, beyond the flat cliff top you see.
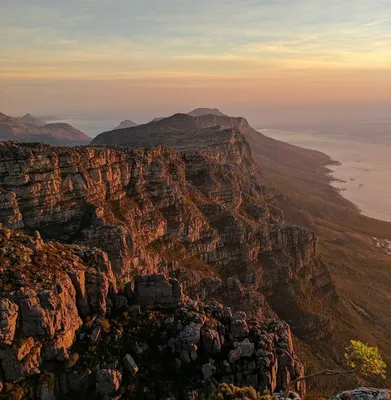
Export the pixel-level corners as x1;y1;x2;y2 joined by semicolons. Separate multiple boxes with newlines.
0;113;91;146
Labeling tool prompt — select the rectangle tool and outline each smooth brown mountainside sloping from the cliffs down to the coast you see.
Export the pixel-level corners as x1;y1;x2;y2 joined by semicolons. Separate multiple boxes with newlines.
90;109;391;389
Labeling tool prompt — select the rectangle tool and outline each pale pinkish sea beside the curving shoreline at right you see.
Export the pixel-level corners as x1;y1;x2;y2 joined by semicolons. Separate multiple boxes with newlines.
259;124;391;222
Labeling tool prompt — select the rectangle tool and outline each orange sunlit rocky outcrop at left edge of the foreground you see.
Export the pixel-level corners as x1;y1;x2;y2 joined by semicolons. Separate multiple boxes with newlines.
0;228;116;382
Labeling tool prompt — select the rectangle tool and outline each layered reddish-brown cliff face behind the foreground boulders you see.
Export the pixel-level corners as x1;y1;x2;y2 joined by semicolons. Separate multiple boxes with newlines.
0;124;330;337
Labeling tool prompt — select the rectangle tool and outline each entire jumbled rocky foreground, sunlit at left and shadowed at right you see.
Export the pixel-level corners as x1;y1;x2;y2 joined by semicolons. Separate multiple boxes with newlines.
0;228;305;399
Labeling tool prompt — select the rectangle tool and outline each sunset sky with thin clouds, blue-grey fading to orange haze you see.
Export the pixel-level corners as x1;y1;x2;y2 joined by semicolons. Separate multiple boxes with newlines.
0;0;391;125
